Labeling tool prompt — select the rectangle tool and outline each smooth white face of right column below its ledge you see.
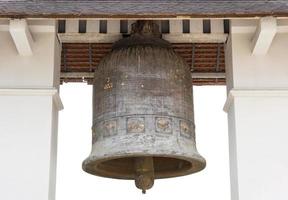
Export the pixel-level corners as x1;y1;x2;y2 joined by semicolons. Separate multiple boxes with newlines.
231;95;288;200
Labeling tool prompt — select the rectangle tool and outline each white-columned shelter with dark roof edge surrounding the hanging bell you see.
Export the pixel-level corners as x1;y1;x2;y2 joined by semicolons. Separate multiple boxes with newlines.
0;0;288;200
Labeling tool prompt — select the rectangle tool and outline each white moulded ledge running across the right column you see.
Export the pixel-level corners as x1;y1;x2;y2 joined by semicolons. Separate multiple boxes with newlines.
223;88;288;112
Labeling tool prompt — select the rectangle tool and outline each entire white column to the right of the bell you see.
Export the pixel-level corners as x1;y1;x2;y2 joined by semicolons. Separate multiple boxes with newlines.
225;19;288;200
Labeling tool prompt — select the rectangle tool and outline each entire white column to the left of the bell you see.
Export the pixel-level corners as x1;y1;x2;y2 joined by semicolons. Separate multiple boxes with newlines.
0;20;62;200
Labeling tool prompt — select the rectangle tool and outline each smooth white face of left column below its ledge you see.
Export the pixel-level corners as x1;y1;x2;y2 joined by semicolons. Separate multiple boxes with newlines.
0;95;54;200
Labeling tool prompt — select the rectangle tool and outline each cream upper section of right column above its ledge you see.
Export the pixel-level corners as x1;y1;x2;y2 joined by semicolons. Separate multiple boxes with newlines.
230;33;288;89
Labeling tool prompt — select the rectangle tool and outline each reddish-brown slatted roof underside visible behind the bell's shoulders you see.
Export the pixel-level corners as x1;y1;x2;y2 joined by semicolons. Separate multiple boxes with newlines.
61;43;225;85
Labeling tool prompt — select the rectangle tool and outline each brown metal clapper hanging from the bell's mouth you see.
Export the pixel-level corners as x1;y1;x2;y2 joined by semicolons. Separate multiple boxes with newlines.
135;157;154;194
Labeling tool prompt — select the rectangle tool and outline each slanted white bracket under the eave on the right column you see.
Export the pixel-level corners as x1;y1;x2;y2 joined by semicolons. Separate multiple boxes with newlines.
252;17;277;55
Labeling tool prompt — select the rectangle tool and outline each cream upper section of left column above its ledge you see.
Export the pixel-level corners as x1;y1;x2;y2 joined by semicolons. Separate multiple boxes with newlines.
0;22;61;88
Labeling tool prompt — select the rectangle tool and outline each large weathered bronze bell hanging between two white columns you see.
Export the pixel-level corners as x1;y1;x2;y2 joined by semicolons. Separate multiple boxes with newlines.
83;21;206;193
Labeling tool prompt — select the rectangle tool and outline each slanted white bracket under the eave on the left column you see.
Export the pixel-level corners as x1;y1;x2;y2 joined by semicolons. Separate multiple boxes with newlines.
9;19;34;56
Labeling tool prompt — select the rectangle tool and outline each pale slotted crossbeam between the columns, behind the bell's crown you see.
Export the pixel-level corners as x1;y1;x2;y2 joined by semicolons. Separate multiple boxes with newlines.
58;19;227;43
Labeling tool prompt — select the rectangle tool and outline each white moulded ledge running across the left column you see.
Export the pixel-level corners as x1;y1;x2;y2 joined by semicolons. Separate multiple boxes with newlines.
0;88;64;110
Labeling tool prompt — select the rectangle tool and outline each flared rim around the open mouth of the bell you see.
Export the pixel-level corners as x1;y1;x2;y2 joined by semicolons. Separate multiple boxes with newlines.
82;154;206;180
